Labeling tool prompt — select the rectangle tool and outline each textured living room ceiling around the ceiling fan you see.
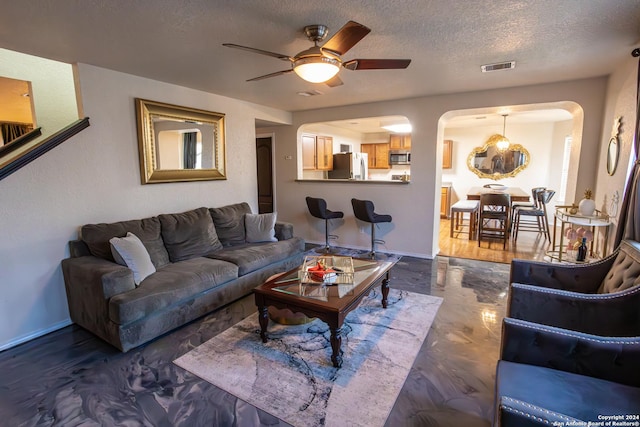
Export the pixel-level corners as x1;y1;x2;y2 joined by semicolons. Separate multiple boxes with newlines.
0;0;640;111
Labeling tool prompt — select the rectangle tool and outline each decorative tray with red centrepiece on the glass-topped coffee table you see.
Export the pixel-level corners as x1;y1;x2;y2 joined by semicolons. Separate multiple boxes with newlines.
300;255;354;285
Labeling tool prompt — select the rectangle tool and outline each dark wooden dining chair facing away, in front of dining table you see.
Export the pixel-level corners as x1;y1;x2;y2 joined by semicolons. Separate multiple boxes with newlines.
478;193;511;249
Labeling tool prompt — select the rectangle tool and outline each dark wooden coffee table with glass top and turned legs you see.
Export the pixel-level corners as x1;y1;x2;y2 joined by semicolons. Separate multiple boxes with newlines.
253;258;396;368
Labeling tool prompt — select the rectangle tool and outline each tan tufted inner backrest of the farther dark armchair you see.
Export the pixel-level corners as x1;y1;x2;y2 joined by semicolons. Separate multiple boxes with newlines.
598;241;640;294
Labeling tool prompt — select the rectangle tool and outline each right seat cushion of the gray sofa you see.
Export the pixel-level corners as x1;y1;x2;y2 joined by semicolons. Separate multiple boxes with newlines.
207;237;304;276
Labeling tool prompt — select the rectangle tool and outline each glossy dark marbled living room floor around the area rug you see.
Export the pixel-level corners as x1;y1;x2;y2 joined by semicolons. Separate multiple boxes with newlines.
0;252;509;427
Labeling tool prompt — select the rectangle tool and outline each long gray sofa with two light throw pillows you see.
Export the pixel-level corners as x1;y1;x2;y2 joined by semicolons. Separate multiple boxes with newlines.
62;203;304;351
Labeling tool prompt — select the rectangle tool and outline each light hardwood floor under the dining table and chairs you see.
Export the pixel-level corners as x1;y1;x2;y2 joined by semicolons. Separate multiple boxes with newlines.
438;218;550;264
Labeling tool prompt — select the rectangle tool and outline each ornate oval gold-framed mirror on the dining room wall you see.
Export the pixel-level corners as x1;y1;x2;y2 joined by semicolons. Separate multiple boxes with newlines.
467;134;531;181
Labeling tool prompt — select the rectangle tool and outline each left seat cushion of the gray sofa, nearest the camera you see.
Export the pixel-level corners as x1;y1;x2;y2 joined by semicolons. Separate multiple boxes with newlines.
109;258;238;325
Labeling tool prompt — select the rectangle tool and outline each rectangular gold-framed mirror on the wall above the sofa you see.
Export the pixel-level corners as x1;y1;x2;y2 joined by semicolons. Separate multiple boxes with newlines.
135;98;227;184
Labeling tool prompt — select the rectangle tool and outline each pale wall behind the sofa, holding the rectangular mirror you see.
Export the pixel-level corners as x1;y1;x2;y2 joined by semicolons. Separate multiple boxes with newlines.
0;64;291;349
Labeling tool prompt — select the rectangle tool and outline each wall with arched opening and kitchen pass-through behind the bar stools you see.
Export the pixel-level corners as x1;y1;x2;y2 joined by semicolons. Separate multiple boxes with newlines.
271;78;607;258
